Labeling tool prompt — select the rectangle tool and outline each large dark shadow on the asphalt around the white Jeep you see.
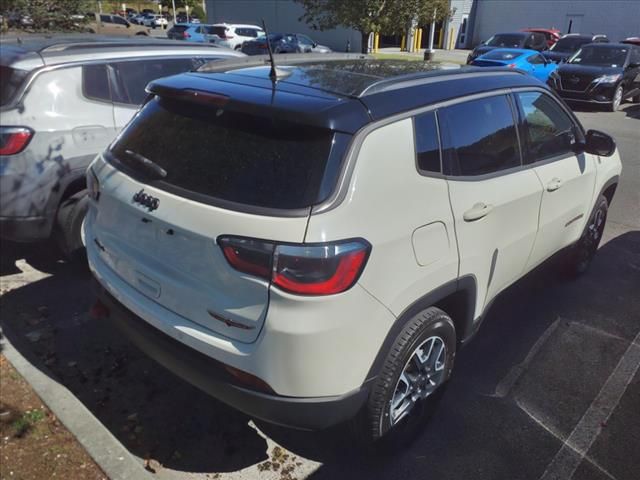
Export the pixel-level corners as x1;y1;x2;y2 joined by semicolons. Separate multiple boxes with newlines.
0;232;640;480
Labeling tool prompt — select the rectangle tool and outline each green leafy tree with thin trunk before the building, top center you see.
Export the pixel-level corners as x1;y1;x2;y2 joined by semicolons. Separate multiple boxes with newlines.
295;0;450;53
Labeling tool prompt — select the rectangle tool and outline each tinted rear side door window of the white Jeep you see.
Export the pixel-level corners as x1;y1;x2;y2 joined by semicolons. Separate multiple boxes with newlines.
441;95;520;175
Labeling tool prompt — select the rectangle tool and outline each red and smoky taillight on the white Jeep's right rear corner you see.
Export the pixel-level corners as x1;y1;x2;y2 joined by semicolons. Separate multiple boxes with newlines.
218;237;371;295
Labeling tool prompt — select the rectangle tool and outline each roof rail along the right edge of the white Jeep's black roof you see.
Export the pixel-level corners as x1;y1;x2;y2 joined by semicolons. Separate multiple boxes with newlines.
359;66;526;97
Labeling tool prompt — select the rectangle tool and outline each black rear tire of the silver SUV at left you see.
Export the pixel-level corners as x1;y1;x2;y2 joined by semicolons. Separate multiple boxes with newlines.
54;190;89;261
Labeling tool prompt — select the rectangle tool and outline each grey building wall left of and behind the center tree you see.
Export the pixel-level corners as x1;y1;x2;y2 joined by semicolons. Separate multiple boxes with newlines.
206;0;361;52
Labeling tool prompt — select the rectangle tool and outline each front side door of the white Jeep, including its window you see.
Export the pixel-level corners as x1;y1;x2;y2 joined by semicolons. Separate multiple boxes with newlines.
515;91;596;268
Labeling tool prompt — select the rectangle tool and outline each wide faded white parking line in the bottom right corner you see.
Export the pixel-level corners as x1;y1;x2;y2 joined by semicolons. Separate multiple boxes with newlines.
540;333;640;480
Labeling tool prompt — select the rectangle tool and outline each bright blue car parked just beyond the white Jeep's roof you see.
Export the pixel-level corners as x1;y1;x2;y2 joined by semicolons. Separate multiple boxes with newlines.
471;48;558;83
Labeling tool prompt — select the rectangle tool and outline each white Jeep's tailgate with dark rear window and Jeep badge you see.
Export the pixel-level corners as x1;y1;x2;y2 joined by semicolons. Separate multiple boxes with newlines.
89;98;340;342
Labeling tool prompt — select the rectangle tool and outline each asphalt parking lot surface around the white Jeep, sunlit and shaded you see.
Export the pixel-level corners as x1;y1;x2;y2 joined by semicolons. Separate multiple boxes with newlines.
0;104;640;480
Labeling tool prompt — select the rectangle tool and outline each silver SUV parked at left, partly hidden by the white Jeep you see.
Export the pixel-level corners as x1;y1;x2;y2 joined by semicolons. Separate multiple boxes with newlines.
0;36;242;255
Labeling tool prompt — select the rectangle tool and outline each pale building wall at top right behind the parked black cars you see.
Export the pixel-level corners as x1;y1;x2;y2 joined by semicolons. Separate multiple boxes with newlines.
473;0;640;45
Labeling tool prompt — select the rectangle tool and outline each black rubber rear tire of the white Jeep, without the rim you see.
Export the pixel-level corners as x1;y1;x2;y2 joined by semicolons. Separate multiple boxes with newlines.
353;307;456;450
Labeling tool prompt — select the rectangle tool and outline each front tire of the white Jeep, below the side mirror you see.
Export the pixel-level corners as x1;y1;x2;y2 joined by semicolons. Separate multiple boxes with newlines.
565;195;609;277
